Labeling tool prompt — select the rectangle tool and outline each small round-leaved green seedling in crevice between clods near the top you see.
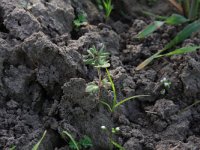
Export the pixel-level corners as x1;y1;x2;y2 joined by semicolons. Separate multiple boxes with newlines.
73;12;88;28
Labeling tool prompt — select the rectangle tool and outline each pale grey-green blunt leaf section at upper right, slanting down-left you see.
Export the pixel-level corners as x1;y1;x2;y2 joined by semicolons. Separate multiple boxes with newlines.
136;21;164;38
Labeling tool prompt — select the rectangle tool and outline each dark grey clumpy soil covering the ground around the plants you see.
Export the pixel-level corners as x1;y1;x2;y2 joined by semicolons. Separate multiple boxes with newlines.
0;0;200;150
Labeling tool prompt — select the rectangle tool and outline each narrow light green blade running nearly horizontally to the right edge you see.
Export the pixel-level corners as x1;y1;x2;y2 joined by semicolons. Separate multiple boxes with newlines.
157;46;200;57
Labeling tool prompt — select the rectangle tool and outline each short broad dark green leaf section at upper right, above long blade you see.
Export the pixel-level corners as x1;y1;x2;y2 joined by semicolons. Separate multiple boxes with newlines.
165;14;189;25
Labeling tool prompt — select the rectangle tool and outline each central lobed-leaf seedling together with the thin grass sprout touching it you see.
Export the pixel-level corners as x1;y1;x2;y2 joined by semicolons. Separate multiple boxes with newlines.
83;45;147;112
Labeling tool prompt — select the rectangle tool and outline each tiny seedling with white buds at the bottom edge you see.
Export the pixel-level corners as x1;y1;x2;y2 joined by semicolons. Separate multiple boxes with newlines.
101;126;125;150
